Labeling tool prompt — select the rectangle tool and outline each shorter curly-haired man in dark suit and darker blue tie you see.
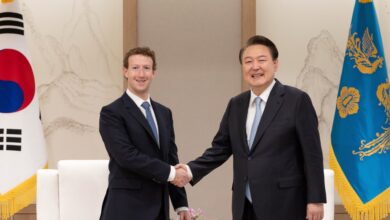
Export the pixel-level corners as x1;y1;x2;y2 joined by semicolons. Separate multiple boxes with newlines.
99;47;190;220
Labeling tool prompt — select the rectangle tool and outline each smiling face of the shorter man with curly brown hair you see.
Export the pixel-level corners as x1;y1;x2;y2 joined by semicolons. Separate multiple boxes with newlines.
123;55;155;99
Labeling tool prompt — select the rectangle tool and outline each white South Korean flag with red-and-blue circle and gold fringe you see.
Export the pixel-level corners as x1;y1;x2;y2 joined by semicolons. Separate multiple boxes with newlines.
0;0;47;220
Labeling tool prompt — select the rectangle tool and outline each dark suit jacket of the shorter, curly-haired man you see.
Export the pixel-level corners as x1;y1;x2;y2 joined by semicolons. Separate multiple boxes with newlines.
99;93;188;220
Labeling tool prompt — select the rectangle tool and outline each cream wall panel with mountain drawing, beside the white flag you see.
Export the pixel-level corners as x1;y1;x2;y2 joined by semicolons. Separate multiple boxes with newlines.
20;0;123;167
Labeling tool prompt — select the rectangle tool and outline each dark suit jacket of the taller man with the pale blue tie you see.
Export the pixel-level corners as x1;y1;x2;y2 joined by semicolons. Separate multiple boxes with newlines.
188;81;326;220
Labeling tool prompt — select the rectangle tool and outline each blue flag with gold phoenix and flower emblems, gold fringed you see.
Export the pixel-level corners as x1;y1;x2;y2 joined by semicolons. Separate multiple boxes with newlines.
330;0;390;219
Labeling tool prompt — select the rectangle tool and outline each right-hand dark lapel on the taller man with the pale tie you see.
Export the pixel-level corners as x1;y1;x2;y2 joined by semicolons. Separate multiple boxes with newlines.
251;81;284;151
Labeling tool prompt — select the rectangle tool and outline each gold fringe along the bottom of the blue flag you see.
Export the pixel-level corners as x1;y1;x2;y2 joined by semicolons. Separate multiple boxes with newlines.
329;146;390;220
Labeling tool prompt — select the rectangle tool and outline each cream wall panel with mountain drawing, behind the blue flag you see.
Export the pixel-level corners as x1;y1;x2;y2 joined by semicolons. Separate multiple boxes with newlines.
256;0;390;203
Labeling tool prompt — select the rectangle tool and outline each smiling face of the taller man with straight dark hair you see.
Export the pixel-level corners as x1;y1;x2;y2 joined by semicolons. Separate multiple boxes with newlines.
242;45;278;95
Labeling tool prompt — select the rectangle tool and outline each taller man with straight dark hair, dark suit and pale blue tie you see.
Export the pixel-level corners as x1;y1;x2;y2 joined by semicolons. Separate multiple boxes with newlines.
177;36;326;220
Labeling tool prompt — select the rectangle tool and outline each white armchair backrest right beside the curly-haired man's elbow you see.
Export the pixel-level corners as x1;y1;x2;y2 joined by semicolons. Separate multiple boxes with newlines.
58;160;108;220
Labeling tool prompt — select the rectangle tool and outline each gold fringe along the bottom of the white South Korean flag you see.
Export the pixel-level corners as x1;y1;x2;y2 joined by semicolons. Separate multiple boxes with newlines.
0;164;48;220
